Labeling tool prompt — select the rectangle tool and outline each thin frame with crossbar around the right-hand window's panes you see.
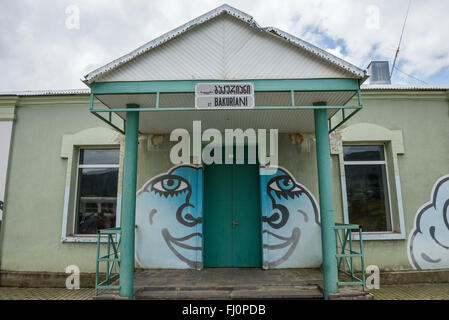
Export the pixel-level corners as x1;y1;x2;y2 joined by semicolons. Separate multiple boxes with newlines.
342;142;394;235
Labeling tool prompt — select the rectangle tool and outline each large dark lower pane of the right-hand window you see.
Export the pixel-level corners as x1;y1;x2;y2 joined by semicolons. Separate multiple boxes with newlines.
345;165;391;231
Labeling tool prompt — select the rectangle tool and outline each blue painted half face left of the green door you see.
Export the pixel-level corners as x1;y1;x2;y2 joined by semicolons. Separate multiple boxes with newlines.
136;166;202;269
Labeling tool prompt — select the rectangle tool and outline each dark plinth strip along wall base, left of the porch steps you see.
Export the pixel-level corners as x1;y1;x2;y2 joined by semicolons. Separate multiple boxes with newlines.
0;270;104;288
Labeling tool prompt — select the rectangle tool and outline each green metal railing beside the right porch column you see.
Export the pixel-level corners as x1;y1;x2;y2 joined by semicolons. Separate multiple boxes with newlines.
335;223;365;290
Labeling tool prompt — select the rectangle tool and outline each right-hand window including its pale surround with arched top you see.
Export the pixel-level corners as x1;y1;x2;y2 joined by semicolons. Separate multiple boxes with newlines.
330;122;406;240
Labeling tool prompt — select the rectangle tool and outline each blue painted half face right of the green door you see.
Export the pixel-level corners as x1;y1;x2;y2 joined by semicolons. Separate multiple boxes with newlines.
261;169;322;268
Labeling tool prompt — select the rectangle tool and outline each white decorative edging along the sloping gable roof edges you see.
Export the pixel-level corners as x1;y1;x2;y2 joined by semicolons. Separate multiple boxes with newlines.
84;4;367;84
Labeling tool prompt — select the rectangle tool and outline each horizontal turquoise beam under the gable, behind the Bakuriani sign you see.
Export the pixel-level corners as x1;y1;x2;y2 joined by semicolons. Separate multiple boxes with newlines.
90;78;359;95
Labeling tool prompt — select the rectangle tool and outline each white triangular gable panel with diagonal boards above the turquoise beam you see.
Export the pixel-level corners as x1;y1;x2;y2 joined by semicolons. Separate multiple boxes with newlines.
99;15;354;82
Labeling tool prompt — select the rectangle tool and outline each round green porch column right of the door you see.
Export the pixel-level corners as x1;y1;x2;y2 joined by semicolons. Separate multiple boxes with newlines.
314;102;338;300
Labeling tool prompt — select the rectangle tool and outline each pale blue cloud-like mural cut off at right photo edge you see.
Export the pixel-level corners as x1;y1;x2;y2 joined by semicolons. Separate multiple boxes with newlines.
408;175;449;269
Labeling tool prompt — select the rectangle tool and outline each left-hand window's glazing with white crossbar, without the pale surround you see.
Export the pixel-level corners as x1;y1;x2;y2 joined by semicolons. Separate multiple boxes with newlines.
75;149;120;235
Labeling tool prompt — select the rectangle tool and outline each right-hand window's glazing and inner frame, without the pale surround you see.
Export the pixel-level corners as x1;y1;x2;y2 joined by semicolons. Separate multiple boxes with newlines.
343;145;392;232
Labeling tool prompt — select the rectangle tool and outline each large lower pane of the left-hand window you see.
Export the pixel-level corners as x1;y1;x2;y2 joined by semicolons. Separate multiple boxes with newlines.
76;168;118;234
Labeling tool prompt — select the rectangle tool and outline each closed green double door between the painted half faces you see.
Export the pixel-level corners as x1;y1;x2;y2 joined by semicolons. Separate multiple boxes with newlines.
203;160;262;267
